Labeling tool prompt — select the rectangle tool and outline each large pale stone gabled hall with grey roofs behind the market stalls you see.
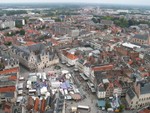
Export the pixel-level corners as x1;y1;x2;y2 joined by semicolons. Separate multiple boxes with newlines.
11;43;59;70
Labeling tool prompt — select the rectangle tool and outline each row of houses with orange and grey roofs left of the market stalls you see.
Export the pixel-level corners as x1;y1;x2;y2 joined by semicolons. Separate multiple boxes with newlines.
0;55;19;103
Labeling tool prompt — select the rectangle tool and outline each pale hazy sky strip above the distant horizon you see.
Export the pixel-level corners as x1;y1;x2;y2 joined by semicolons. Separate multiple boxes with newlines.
0;0;150;6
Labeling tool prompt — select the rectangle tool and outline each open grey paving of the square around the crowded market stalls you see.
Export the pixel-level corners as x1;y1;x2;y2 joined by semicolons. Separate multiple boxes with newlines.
20;64;136;113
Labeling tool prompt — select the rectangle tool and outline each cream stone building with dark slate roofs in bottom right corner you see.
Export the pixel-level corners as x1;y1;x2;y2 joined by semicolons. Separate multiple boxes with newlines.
126;81;150;109
